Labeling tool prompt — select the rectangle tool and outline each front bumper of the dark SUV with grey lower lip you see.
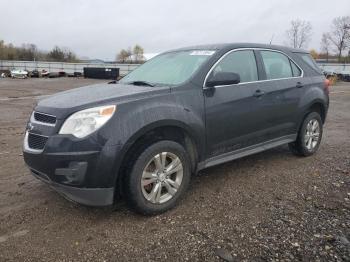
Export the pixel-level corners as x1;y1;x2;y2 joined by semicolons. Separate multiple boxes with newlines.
23;135;121;206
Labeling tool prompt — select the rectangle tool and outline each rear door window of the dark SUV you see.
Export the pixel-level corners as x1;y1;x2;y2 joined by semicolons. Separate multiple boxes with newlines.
260;51;293;79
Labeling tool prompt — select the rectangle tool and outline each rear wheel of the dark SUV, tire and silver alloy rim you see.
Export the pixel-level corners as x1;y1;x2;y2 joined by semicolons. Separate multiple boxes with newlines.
288;112;323;156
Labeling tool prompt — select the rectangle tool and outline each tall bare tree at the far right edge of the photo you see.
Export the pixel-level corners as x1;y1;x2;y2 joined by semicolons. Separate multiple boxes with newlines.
329;16;350;61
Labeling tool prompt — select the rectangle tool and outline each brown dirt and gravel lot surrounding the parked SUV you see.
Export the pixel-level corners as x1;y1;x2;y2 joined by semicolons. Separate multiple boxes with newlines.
0;78;350;261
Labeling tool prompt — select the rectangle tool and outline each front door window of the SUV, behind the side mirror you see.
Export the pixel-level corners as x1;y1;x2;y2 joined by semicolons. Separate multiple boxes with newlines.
212;50;258;83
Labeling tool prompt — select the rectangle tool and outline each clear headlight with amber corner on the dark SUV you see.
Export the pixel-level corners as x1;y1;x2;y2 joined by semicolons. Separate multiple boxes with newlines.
59;105;116;138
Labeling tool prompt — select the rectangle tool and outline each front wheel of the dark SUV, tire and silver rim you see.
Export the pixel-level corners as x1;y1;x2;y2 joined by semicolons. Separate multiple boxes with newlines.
124;140;191;215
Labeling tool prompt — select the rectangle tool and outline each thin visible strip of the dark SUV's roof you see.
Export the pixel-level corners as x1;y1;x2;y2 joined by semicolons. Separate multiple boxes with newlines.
171;43;309;53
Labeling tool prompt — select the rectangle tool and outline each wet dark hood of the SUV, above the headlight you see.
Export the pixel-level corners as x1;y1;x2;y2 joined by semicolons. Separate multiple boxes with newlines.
35;83;170;119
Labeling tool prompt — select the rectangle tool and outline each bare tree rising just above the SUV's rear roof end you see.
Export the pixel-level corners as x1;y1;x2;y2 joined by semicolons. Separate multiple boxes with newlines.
286;19;312;48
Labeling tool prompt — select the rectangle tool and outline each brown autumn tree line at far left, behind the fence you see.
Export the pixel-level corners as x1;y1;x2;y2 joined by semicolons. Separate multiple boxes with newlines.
0;40;79;62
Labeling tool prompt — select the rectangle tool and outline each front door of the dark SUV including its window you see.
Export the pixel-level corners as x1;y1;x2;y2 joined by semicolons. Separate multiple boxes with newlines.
204;50;266;158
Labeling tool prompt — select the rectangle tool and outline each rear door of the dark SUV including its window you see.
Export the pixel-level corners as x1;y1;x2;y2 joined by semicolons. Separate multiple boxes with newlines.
259;50;305;140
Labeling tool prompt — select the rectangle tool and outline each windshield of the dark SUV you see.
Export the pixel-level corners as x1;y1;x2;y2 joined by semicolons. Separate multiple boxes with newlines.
120;50;215;85
